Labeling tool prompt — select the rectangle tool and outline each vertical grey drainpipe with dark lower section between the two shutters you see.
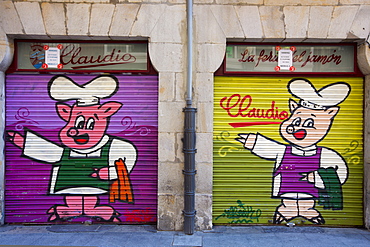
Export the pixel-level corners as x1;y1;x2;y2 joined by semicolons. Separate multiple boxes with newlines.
183;0;197;235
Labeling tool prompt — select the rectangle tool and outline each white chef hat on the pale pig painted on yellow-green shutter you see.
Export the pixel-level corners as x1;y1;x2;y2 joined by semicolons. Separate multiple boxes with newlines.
288;78;351;109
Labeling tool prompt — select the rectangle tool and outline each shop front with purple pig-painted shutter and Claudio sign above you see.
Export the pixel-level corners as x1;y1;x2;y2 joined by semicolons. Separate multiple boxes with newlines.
5;40;158;224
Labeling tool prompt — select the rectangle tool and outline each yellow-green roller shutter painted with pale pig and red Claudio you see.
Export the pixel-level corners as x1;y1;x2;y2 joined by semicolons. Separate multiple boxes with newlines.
213;77;363;226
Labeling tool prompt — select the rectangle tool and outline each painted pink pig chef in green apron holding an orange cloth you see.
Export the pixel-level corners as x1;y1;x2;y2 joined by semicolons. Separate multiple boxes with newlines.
8;76;137;222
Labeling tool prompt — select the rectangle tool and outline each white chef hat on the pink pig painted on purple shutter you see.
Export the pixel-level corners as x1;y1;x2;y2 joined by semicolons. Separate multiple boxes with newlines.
49;76;118;106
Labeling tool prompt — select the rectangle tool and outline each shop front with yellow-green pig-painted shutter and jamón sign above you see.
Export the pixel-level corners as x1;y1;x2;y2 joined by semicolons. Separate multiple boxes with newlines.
213;43;364;226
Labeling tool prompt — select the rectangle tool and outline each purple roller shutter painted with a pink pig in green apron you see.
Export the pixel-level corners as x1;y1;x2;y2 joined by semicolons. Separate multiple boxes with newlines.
5;75;158;224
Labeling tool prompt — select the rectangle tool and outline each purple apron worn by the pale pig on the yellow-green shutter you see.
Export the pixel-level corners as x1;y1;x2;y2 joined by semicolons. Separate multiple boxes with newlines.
274;146;321;197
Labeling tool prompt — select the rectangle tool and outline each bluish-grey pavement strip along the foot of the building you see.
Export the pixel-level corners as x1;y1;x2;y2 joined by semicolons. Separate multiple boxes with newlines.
0;225;370;247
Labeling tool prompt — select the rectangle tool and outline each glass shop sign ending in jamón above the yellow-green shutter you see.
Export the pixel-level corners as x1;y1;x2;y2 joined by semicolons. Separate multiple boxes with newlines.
225;44;354;73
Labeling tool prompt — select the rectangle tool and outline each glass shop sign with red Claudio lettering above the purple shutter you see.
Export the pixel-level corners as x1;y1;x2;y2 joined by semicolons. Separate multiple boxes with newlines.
17;42;148;71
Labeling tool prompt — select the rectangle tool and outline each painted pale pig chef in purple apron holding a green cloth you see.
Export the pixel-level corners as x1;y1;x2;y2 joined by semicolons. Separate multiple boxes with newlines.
236;79;350;224
